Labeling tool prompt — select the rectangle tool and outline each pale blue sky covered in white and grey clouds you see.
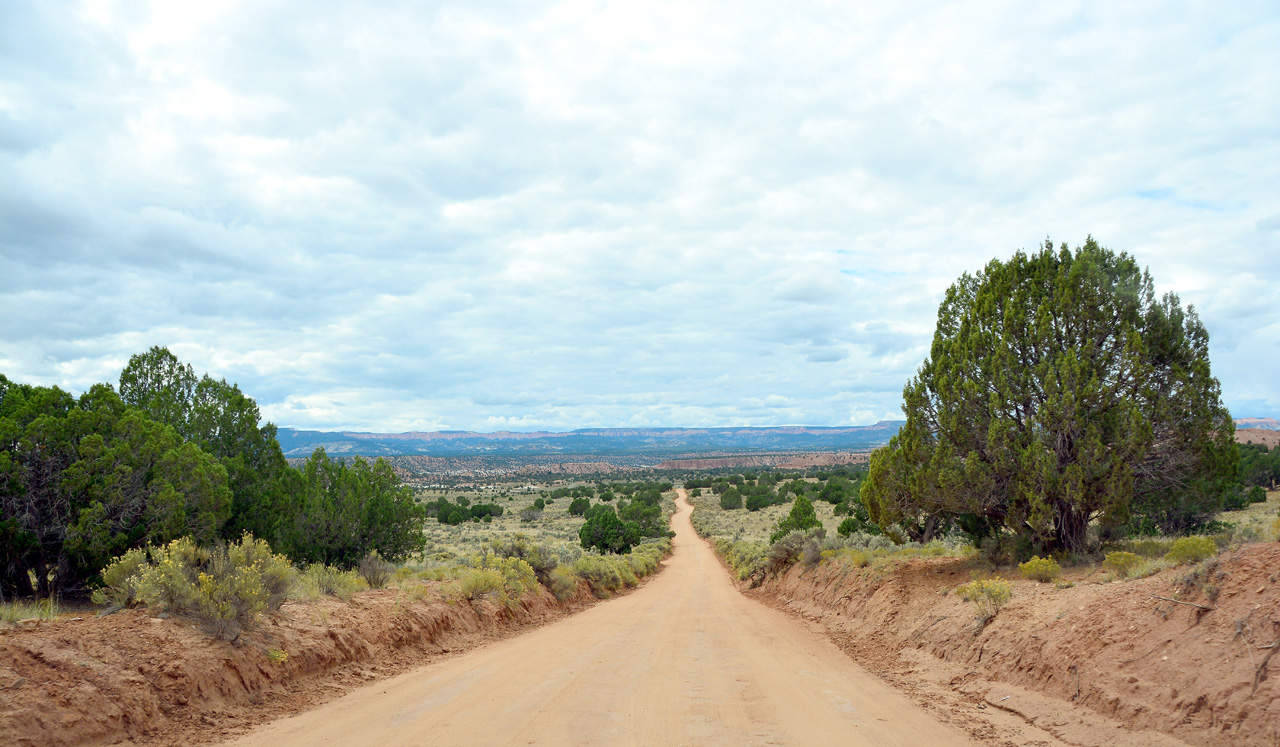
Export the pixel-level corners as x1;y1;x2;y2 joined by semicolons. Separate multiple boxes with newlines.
0;0;1280;431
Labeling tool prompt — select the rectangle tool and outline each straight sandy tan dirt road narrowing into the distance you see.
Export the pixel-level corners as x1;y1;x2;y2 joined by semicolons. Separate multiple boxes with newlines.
225;492;972;747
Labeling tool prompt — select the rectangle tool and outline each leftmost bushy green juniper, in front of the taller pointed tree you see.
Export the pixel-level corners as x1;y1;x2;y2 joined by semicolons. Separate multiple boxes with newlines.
0;376;232;596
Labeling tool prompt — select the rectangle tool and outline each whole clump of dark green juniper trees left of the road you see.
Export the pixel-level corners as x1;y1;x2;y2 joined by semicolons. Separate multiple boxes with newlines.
0;348;430;596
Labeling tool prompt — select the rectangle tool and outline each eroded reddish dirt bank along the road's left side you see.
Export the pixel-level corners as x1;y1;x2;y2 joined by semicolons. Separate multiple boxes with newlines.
0;585;609;746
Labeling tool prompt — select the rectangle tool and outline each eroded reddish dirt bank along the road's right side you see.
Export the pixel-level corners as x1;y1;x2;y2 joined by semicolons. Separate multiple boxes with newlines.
749;544;1280;746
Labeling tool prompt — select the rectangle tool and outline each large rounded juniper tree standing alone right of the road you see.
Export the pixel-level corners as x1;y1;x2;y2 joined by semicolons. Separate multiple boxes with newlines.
861;237;1235;550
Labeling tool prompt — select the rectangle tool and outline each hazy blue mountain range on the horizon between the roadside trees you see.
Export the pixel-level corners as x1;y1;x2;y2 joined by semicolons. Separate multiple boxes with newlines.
276;421;902;458
